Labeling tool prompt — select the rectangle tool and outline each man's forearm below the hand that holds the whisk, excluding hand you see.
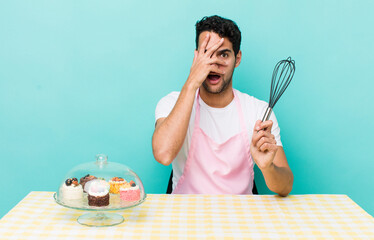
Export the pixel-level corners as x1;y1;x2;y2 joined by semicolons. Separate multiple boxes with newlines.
260;163;293;197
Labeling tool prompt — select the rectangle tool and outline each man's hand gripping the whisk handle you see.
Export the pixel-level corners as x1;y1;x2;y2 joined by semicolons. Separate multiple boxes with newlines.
250;120;278;170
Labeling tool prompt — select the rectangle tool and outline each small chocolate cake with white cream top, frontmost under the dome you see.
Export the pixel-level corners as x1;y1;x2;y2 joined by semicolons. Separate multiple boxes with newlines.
86;179;109;207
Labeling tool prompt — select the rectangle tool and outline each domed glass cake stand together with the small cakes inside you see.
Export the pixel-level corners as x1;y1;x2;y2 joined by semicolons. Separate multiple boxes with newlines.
54;154;146;226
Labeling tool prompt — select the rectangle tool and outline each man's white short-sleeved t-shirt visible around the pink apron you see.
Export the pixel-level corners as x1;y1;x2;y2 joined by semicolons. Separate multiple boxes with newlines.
156;89;282;189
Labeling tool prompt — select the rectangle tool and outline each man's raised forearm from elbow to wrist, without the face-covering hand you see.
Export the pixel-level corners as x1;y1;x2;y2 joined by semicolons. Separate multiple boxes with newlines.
152;80;197;165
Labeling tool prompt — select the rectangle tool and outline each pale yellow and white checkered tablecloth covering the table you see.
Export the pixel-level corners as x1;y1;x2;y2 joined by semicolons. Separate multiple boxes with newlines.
0;192;374;240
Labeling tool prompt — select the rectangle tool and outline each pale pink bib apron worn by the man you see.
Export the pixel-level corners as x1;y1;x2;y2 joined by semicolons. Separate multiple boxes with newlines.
173;91;254;194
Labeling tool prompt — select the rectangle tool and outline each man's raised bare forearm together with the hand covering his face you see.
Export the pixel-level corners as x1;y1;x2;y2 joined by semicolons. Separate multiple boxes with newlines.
152;34;227;165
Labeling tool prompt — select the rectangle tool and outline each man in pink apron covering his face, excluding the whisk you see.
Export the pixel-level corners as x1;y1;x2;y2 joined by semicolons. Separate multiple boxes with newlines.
152;16;293;196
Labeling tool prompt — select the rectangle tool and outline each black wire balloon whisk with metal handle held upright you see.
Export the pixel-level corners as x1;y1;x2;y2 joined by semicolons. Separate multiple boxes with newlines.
262;57;295;121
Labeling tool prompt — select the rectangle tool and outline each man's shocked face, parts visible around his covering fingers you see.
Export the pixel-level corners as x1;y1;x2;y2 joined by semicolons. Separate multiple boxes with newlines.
198;31;241;94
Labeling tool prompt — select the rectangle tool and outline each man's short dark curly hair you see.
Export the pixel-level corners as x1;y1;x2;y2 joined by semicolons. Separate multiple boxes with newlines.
196;15;242;56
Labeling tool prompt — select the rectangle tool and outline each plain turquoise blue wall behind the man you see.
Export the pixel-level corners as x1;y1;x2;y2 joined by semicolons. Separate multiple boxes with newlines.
0;0;374;217
